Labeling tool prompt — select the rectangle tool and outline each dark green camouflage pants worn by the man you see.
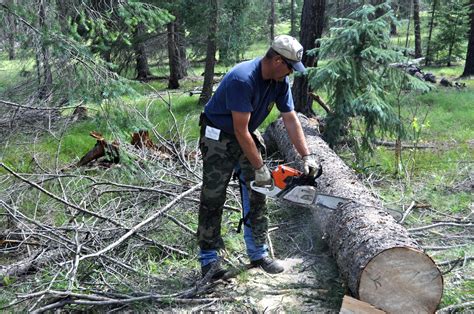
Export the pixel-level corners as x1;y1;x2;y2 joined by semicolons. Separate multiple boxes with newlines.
197;118;268;250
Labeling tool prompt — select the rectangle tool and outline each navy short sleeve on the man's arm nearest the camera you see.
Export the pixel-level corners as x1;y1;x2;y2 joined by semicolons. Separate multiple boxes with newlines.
225;79;254;112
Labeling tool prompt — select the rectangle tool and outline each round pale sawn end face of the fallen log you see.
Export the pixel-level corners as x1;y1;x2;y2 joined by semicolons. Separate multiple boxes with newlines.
358;247;443;313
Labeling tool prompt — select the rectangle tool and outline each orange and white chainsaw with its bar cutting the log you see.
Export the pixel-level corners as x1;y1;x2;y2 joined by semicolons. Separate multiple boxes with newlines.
250;165;349;210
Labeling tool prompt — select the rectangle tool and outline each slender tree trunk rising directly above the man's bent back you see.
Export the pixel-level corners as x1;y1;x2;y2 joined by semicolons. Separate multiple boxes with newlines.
199;0;218;106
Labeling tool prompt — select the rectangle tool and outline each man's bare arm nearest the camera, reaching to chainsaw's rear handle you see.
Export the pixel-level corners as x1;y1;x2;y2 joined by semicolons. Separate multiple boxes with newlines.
232;111;264;169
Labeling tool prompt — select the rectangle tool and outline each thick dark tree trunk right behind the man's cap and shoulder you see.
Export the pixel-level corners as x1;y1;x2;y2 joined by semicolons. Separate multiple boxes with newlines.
292;0;326;117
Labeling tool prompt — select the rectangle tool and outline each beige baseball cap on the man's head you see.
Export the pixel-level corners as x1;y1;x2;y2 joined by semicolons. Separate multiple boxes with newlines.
271;35;306;72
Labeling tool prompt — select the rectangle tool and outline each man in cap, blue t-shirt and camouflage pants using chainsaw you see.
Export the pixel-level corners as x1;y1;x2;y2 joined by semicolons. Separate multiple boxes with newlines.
197;35;318;279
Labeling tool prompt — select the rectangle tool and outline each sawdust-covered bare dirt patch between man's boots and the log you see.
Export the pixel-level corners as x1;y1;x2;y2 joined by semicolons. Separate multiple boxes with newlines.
174;204;345;313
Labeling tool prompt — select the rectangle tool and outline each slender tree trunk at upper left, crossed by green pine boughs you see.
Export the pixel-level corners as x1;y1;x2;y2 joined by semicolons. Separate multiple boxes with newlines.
38;0;53;99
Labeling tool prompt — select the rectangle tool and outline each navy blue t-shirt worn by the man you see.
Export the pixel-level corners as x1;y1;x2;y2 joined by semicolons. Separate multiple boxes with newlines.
204;58;294;134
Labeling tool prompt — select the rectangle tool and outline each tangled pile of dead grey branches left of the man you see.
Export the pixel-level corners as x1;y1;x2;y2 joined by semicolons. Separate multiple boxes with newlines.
0;116;238;312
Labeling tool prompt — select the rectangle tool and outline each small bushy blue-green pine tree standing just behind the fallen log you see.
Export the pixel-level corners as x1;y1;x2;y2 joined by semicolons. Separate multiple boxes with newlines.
309;4;428;161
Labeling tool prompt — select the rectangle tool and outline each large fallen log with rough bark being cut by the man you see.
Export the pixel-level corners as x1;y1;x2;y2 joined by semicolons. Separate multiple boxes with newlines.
265;115;443;313
